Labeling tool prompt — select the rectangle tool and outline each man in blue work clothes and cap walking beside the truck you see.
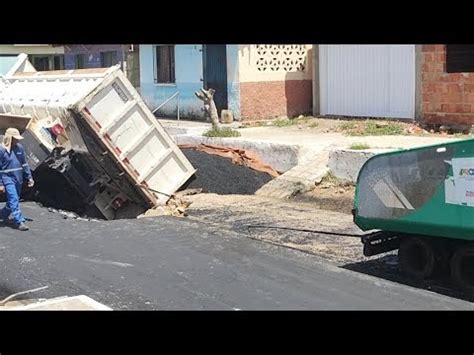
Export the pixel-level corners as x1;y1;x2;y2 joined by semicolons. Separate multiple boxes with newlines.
0;128;35;231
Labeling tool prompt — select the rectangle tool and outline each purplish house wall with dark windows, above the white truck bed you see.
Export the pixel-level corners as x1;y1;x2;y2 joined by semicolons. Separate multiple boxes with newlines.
64;44;123;69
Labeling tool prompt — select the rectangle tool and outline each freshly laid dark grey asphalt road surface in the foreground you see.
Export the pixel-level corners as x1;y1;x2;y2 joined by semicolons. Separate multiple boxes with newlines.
0;203;474;310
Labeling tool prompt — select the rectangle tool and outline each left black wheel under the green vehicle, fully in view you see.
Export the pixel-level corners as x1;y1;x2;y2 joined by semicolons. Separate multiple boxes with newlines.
398;237;437;280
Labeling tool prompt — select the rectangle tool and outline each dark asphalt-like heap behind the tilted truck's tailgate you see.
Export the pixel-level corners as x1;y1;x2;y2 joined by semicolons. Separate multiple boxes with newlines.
181;148;272;195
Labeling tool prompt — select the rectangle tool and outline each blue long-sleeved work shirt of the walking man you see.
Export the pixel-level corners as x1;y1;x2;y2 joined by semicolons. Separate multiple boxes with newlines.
0;143;32;185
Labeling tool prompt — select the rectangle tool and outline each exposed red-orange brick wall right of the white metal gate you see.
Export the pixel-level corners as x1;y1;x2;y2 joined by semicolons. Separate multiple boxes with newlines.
421;45;474;124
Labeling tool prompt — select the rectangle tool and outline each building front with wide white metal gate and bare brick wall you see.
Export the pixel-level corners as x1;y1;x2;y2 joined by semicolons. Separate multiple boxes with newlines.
313;45;474;125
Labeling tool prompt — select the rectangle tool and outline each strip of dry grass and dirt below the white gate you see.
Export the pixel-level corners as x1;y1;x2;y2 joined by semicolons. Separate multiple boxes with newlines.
338;121;404;136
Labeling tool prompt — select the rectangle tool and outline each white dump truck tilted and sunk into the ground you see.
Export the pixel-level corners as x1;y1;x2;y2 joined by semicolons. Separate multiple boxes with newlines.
0;54;195;219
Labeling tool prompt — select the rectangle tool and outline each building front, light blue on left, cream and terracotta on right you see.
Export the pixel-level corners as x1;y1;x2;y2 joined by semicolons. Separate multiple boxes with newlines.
140;44;312;120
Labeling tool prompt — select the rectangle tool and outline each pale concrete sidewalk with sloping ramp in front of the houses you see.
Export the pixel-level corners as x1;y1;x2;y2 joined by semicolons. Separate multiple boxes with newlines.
160;118;467;199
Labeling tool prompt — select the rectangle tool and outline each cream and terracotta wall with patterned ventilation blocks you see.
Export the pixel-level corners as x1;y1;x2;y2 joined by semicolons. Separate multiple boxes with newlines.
239;45;313;119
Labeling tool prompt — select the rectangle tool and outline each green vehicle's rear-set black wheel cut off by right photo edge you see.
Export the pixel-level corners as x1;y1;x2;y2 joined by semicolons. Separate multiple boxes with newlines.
451;244;474;296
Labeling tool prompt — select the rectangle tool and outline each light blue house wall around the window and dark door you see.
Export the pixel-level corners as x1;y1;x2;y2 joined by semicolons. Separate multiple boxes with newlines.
140;44;240;119
